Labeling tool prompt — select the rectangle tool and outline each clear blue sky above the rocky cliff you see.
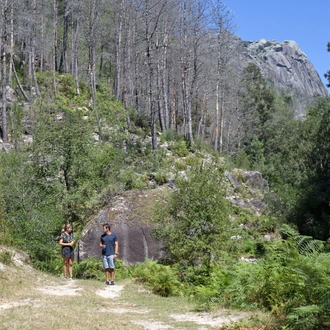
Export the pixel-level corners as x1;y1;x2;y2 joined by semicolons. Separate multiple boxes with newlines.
223;0;330;90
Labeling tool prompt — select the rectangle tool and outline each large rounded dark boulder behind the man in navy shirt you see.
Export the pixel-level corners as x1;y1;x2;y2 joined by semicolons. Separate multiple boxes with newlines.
77;187;166;264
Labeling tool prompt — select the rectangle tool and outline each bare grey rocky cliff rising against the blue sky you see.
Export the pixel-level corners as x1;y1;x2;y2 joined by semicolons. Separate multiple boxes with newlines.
239;39;328;116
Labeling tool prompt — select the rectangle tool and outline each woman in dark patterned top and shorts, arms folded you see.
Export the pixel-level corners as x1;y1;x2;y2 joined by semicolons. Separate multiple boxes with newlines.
60;223;74;280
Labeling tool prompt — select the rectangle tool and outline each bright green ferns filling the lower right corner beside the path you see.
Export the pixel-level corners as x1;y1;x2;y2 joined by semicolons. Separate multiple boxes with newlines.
191;226;330;329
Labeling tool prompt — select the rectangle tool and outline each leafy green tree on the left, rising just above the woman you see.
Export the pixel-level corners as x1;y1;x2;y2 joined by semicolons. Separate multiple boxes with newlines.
32;110;93;221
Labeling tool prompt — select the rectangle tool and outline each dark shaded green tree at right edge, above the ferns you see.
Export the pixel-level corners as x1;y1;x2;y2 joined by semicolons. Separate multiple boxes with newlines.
294;97;330;239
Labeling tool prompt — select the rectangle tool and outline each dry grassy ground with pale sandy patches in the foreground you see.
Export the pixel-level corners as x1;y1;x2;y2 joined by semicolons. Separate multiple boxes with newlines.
0;250;268;330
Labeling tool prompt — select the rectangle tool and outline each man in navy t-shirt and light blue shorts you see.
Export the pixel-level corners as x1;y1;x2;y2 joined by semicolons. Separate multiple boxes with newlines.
100;223;118;285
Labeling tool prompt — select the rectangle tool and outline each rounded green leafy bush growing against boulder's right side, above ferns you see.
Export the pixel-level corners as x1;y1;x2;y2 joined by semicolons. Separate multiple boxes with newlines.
155;163;228;272
